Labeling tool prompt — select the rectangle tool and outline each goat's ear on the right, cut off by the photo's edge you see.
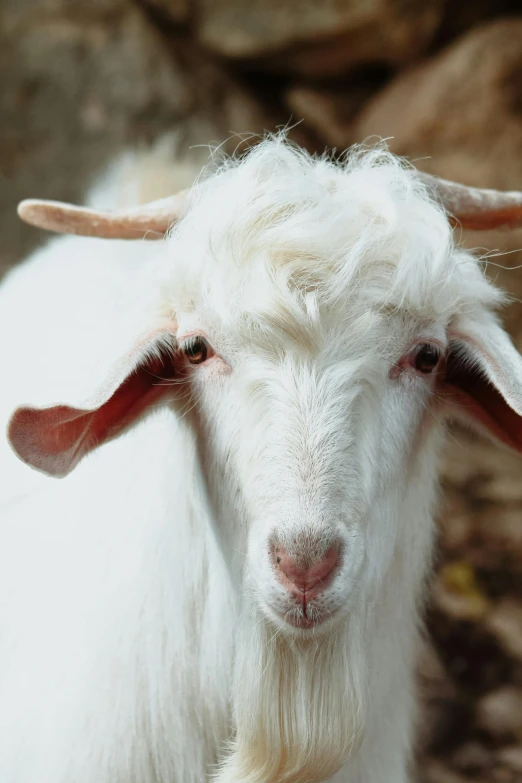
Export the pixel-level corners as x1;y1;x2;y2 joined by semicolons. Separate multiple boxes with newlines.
439;318;522;452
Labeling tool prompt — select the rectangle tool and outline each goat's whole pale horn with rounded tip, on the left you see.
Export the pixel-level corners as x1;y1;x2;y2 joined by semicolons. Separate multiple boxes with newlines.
18;190;187;239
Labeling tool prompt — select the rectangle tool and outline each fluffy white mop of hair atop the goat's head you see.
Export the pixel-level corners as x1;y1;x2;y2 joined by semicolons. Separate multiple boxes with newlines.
164;144;500;341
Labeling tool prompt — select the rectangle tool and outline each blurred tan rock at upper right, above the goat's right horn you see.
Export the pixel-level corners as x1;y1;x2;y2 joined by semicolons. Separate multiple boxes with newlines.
355;17;522;188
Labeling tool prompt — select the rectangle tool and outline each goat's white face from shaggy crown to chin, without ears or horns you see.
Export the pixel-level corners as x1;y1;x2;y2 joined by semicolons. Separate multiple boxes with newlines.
156;145;456;635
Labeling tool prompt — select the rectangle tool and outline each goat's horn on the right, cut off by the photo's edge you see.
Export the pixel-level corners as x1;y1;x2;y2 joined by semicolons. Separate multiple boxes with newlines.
419;172;522;231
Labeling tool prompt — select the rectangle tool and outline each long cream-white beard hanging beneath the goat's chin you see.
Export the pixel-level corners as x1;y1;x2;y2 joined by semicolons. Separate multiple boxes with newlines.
216;605;366;783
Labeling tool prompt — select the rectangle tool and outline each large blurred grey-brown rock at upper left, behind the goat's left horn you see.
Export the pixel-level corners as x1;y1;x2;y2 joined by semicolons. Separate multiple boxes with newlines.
0;0;269;274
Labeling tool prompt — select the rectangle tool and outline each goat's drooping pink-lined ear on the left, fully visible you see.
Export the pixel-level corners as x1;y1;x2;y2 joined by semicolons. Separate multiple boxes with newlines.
7;329;179;477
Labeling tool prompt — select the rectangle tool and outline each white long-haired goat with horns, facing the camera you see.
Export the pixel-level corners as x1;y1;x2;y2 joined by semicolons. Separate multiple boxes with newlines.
0;140;522;783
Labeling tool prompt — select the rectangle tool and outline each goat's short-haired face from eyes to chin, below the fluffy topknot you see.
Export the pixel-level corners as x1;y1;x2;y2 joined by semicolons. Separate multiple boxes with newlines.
171;293;445;633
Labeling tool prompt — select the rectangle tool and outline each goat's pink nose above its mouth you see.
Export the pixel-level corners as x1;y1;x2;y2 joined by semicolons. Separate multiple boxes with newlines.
273;546;340;600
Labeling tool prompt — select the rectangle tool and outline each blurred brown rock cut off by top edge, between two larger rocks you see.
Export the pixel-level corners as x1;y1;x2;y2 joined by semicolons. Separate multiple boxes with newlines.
191;0;444;76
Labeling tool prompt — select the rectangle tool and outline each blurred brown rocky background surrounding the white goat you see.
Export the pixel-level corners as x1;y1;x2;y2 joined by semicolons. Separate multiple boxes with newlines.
0;0;522;783
